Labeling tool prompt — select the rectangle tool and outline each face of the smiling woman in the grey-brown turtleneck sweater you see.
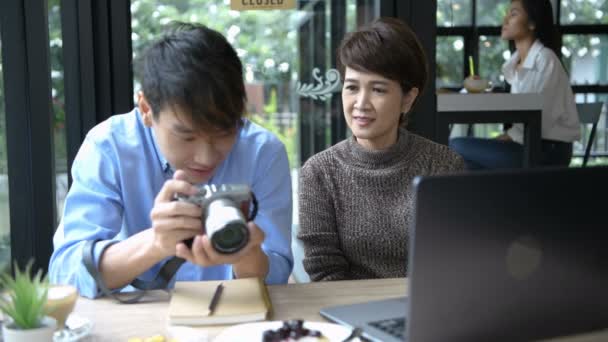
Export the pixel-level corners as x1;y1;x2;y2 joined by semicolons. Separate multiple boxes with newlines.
342;67;418;150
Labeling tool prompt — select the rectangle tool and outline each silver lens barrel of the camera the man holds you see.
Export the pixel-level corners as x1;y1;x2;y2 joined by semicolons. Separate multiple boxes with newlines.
205;198;249;254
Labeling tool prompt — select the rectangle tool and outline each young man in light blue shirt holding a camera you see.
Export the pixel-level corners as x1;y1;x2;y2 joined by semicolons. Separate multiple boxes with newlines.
49;24;293;297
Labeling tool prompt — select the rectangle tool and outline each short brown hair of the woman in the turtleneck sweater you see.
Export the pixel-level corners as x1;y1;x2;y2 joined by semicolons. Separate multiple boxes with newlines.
336;17;428;107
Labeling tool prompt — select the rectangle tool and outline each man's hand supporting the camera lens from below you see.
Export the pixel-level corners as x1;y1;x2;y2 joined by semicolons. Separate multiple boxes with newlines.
177;222;268;278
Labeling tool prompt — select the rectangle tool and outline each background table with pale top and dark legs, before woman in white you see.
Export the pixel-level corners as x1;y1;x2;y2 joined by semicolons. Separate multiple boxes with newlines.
436;93;543;167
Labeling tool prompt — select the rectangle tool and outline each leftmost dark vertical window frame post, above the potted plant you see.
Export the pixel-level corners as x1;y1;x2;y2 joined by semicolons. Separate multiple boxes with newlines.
0;0;56;270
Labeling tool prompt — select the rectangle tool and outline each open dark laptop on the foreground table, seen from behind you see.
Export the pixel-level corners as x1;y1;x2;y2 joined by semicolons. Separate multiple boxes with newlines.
321;167;608;342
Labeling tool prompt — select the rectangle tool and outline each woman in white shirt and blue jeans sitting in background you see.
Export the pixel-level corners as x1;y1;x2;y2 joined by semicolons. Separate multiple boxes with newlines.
450;0;580;169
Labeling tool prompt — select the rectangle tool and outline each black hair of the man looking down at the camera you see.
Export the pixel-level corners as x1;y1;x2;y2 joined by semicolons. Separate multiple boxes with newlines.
141;23;247;130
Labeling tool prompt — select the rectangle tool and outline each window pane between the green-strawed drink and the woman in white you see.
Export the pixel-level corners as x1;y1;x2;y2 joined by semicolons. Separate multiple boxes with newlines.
478;36;511;87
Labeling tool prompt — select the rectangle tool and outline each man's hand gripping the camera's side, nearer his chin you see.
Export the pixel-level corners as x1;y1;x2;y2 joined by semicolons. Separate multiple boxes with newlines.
150;170;203;257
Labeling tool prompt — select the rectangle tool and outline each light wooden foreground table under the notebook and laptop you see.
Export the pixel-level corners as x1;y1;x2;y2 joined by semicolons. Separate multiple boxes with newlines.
75;278;608;342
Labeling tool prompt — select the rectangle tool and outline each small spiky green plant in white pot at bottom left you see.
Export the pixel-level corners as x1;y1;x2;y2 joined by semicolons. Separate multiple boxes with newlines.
0;262;57;342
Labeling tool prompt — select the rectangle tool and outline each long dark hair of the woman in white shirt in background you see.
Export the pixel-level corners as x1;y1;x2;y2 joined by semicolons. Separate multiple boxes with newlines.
511;0;559;55
